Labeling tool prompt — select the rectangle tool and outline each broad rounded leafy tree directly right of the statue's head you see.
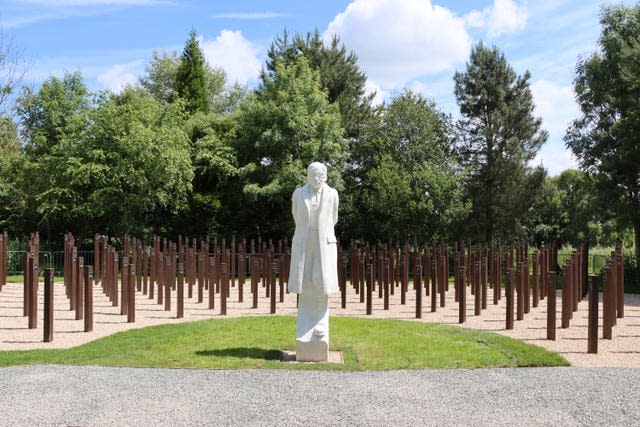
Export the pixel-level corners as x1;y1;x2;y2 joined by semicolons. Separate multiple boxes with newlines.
343;91;469;242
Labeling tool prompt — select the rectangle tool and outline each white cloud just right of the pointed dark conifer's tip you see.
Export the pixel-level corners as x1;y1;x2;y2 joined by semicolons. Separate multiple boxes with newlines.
200;30;262;84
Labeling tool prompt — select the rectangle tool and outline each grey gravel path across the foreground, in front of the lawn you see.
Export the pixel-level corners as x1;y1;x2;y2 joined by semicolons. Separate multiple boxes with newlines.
0;366;640;426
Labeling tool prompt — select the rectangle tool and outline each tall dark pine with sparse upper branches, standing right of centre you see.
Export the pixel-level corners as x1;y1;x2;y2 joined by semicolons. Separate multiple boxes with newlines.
454;43;547;241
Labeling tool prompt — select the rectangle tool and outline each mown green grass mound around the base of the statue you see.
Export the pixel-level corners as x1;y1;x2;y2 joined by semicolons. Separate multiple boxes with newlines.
0;316;568;371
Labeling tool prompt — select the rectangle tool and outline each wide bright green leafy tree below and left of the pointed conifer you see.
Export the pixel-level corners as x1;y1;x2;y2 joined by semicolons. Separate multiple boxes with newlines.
82;90;194;236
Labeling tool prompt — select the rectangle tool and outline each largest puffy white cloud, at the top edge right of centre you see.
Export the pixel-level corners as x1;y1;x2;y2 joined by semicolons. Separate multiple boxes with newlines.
323;0;472;90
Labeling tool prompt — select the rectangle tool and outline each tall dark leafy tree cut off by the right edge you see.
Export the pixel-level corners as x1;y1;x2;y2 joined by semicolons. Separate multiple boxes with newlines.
565;6;640;265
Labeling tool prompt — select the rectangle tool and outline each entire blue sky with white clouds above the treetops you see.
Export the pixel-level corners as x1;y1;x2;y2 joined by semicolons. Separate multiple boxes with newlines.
0;0;634;175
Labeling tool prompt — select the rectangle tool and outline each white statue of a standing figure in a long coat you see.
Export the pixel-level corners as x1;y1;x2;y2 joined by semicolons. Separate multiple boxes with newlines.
288;162;339;362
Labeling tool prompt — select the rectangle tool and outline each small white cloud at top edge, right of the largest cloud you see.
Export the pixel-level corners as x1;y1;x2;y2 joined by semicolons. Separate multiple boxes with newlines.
464;0;527;38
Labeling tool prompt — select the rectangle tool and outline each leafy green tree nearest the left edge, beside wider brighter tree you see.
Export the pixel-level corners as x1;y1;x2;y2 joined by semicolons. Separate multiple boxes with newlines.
15;72;93;240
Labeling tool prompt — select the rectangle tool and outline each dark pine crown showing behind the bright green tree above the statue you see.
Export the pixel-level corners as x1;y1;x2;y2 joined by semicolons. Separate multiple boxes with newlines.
266;29;375;139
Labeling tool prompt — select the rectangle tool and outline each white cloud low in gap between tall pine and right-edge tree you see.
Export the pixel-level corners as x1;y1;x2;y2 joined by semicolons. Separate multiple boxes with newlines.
531;80;580;175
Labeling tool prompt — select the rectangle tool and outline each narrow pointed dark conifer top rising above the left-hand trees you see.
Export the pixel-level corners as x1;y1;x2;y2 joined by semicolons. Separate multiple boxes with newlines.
174;29;209;113
